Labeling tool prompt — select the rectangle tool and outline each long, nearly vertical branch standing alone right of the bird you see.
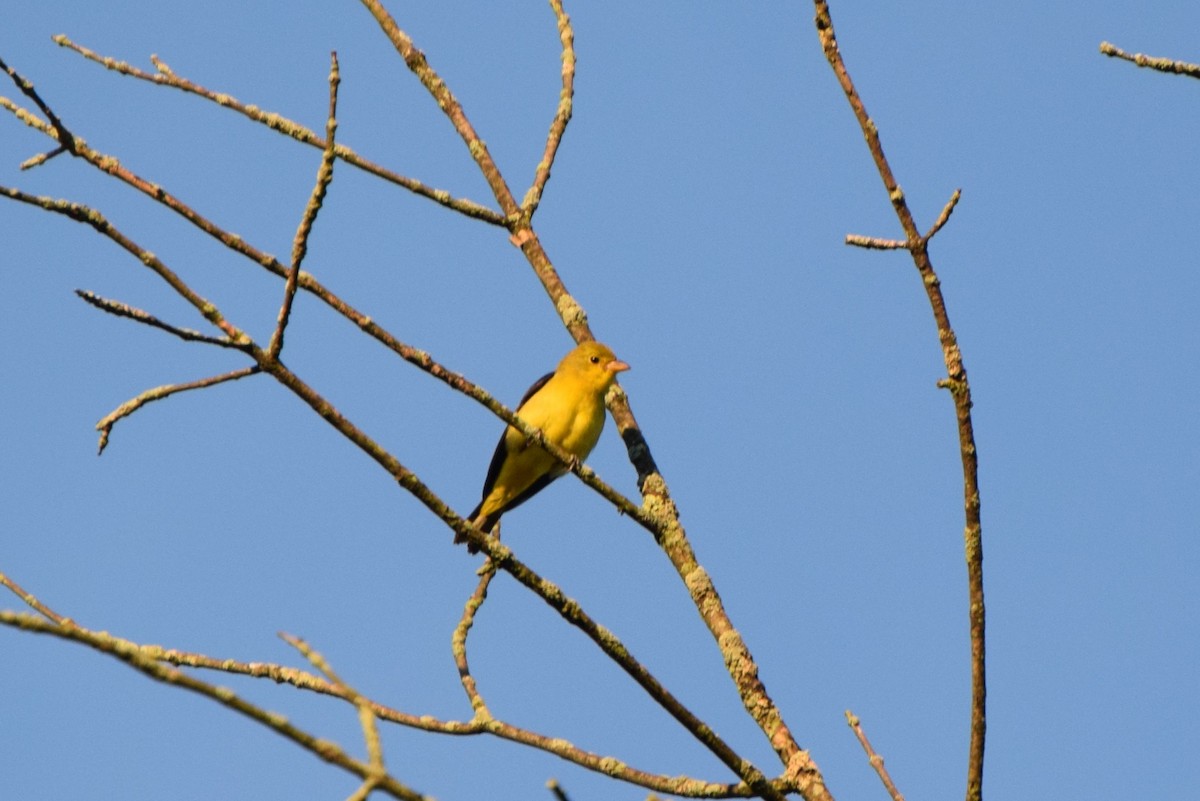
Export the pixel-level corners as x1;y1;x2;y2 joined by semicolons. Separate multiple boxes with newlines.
814;0;988;801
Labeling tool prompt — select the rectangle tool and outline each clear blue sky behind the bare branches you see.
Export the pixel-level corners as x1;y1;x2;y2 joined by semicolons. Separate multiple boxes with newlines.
0;0;1200;801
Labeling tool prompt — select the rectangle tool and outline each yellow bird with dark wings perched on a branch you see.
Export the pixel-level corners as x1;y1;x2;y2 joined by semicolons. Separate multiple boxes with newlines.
455;342;629;553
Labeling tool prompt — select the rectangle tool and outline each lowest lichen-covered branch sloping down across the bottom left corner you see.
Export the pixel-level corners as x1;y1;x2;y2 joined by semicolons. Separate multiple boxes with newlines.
0;610;432;801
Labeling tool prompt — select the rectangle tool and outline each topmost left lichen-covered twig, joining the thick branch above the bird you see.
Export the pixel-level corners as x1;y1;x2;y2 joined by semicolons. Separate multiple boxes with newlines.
54;35;504;225
